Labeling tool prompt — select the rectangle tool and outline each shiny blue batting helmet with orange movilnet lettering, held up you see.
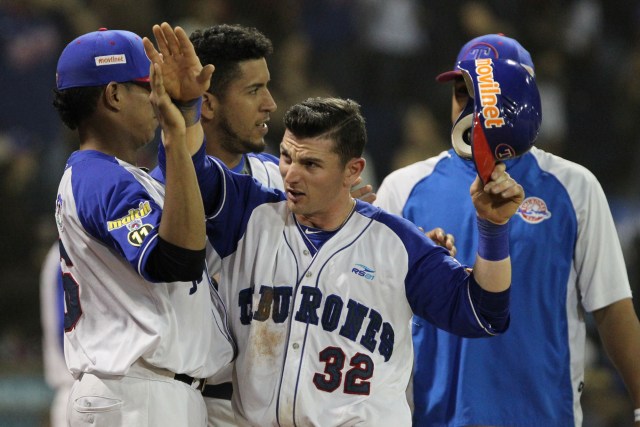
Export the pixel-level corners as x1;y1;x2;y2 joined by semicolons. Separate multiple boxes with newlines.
452;58;542;183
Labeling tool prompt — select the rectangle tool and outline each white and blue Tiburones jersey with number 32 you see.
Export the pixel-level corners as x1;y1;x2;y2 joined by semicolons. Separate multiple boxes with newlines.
184;151;508;426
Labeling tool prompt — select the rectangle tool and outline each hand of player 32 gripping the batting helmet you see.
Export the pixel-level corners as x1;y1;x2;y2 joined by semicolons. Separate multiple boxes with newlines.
469;163;524;224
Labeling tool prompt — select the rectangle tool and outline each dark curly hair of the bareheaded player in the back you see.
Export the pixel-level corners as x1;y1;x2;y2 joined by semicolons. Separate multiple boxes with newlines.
189;24;273;97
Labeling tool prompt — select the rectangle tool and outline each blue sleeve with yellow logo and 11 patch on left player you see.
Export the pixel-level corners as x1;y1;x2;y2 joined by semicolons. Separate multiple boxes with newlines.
72;161;162;281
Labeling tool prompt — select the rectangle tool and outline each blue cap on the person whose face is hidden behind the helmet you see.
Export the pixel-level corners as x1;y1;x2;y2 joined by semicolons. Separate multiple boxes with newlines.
436;33;535;83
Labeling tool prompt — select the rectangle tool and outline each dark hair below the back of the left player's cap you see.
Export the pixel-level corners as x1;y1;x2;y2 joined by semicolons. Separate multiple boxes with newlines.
53;86;105;130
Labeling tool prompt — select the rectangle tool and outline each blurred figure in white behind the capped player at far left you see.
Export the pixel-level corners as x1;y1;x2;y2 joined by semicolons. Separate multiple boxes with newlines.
40;241;73;427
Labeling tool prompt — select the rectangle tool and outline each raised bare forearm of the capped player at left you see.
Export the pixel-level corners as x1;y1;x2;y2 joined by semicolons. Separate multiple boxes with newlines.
159;130;206;250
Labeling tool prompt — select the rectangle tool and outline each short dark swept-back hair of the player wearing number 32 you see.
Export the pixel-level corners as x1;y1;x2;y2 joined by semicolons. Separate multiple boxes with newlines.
284;98;367;165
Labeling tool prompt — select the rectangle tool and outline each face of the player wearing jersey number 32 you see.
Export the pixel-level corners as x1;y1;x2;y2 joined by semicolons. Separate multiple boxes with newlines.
280;130;364;230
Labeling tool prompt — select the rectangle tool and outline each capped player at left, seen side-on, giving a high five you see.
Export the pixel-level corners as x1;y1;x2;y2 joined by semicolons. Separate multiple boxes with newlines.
54;23;234;426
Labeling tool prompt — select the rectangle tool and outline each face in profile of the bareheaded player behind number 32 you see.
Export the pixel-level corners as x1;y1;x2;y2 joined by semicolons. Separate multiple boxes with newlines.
203;58;277;167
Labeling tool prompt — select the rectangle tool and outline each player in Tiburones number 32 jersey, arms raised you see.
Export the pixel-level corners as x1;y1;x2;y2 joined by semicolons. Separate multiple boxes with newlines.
159;98;523;426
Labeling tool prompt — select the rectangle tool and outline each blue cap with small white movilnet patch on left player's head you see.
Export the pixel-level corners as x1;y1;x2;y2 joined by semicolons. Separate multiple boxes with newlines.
56;28;151;90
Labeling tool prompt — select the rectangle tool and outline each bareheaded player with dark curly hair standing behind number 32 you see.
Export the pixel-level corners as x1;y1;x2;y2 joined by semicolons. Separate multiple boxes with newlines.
151;24;373;427
